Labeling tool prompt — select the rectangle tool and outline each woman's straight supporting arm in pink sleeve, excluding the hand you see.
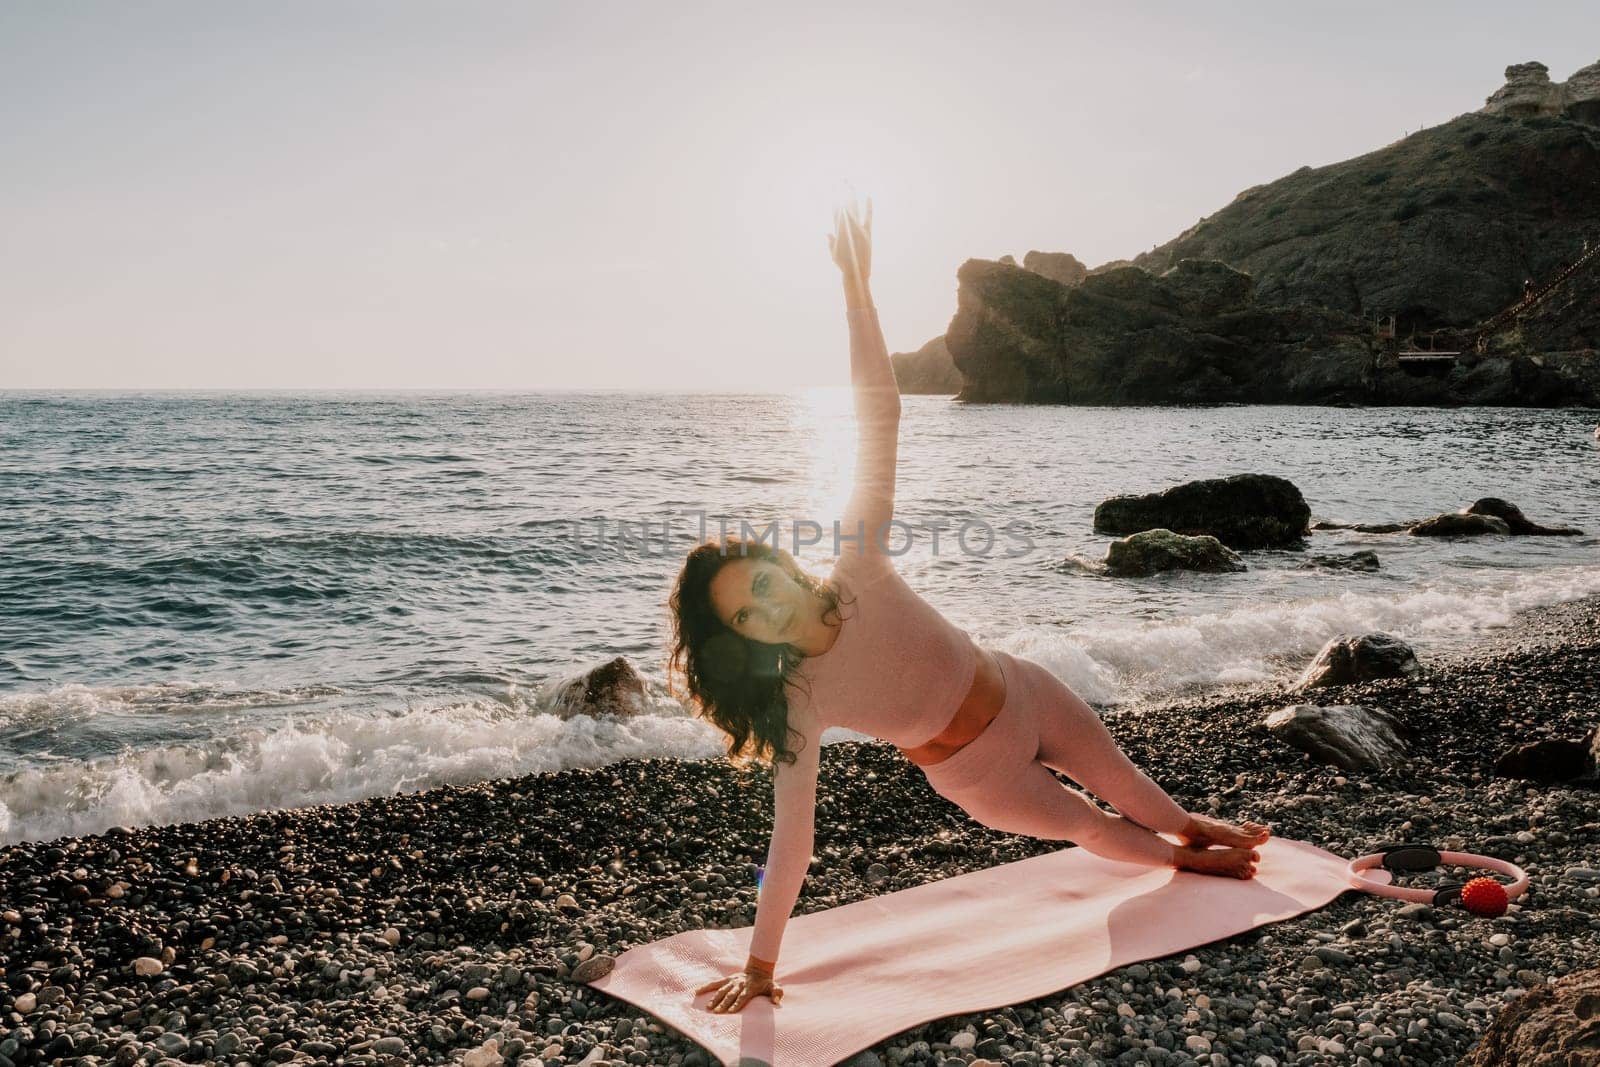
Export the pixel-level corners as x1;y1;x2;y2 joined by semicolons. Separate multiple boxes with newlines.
746;689;822;976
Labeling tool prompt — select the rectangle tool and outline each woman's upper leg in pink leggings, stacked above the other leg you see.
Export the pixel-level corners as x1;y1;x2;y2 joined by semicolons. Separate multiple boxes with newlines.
1003;657;1189;833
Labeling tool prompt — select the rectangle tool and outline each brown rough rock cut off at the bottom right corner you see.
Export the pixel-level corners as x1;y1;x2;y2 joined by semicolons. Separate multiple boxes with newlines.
1461;969;1600;1067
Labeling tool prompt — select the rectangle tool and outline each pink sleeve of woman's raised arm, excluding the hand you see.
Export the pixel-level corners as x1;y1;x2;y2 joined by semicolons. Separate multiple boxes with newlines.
838;280;901;555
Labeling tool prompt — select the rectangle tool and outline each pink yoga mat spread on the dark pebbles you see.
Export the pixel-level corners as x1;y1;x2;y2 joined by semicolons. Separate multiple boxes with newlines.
590;838;1376;1067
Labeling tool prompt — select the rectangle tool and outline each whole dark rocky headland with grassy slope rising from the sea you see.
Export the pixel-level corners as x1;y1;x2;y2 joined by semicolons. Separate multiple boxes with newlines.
946;64;1600;405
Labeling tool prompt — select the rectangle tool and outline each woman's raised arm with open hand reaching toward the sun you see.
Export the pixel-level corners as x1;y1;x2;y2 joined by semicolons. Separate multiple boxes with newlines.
827;200;901;553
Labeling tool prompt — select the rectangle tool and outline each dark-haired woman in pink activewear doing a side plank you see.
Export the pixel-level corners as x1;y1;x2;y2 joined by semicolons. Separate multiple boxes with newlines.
670;200;1269;1013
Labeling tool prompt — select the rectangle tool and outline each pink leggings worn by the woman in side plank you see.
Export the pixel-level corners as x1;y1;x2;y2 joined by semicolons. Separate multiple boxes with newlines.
922;649;1189;865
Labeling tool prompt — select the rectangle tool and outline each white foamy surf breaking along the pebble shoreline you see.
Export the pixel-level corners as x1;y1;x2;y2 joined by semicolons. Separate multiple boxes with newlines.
0;566;1600;843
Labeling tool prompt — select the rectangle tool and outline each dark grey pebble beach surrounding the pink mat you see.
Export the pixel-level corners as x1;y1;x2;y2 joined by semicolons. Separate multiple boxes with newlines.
0;598;1600;1067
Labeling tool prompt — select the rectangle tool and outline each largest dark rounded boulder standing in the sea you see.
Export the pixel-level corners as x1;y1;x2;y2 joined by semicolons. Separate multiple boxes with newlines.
1094;474;1310;549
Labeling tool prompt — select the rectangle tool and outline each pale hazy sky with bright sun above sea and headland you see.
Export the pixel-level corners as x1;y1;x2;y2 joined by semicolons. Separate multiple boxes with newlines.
0;0;1600;392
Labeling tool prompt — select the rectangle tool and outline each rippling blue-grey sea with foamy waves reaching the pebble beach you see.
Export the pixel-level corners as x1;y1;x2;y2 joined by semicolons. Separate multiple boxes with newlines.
0;389;1600;843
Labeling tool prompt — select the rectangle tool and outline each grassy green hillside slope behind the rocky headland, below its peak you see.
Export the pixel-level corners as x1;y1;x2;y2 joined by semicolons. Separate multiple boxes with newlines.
1134;114;1600;338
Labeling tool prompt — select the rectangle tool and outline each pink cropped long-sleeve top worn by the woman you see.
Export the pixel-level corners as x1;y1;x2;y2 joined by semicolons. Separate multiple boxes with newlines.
750;307;978;963
